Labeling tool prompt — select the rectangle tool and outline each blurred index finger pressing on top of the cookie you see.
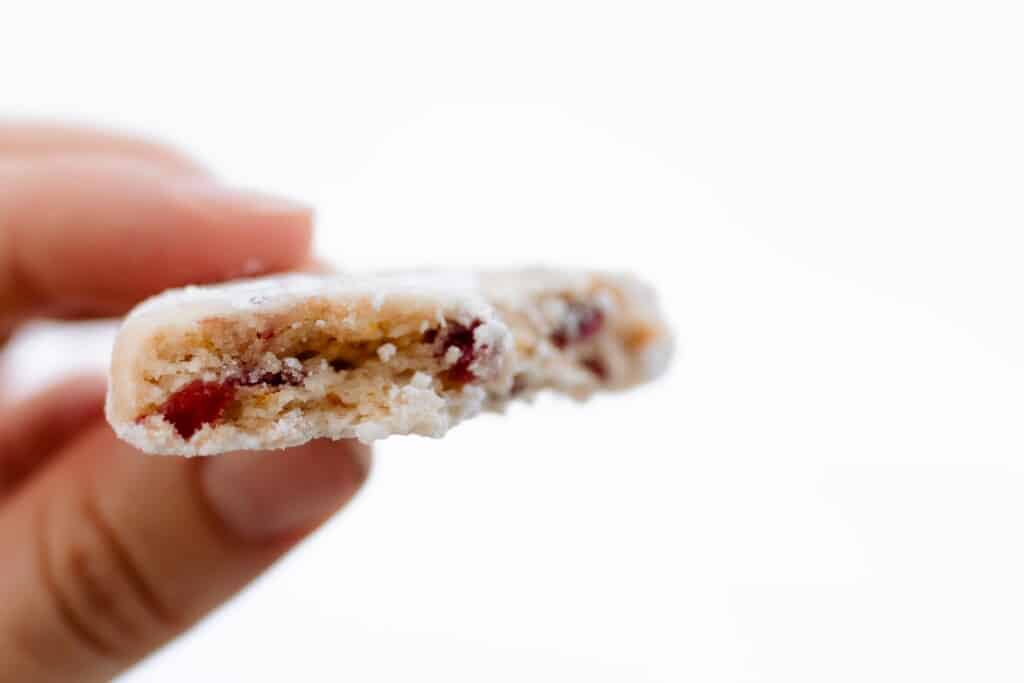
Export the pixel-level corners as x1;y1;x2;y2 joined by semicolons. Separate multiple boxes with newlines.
0;158;311;321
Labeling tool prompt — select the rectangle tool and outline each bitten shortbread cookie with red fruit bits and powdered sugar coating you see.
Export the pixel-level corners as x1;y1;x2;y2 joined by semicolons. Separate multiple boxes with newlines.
106;269;671;456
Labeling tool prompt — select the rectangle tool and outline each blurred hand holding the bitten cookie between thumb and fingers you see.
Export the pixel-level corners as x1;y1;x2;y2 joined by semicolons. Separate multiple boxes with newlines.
0;120;369;682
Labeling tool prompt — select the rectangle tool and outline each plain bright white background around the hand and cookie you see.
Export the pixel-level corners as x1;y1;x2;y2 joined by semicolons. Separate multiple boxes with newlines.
0;0;1024;683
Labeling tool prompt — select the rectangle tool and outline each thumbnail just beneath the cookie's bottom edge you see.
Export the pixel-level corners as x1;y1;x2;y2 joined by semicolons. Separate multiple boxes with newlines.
201;440;370;541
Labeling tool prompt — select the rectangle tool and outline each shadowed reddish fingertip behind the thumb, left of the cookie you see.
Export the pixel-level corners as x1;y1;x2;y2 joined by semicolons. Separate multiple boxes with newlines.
0;377;106;502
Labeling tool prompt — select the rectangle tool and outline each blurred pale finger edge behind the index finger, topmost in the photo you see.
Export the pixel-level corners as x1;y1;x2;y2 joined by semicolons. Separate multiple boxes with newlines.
0;121;208;175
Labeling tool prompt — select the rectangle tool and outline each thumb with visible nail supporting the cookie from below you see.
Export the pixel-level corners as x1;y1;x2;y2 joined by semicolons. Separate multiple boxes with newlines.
0;426;368;683
